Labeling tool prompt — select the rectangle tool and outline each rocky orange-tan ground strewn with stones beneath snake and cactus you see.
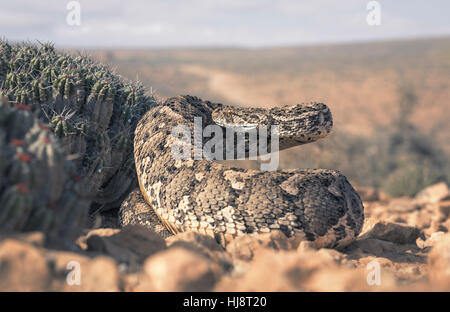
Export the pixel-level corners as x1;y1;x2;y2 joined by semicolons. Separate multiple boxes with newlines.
0;183;450;291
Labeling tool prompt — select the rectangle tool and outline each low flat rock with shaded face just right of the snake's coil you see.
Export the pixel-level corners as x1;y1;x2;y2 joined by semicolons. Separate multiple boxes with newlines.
360;220;425;244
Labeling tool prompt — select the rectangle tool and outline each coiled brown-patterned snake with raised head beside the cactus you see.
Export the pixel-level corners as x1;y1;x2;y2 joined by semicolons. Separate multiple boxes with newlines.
119;96;364;248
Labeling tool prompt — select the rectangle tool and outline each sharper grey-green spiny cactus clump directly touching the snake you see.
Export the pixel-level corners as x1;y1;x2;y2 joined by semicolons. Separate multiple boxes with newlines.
0;40;156;209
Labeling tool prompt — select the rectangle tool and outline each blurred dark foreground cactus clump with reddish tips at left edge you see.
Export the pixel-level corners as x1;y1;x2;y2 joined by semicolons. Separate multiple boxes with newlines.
0;98;90;245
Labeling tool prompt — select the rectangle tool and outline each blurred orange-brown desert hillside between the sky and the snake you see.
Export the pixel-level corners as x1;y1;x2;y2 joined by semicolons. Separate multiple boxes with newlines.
80;37;450;195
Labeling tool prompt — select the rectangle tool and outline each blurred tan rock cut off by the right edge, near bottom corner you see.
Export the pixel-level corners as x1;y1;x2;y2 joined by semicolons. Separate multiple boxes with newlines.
428;234;450;291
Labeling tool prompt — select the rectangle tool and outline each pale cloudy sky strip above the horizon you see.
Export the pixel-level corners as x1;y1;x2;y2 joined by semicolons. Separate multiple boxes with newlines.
0;0;450;47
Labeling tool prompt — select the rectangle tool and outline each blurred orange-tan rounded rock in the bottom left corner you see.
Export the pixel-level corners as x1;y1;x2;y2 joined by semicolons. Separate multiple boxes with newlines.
0;239;51;291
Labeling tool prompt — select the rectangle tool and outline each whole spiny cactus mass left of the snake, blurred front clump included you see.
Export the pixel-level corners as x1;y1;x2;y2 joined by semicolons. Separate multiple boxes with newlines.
0;40;156;243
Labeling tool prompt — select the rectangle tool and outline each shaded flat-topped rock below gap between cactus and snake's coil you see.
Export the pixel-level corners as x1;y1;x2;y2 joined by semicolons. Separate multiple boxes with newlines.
86;225;166;271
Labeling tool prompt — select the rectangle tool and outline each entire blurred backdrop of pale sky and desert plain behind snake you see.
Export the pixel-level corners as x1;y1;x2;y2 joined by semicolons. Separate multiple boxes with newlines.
0;0;450;196
